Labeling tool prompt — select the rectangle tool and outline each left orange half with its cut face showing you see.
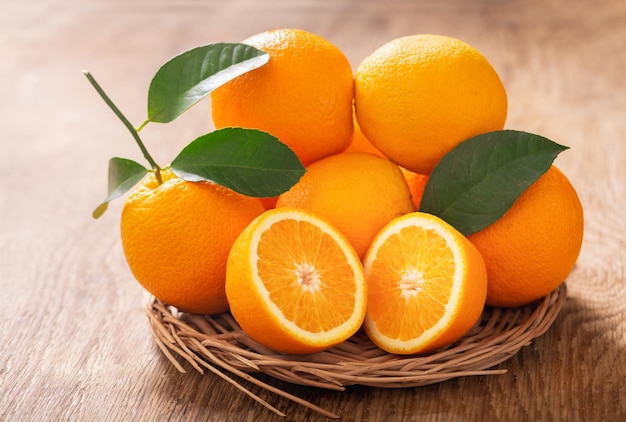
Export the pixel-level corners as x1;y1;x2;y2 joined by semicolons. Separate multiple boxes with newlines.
226;208;367;354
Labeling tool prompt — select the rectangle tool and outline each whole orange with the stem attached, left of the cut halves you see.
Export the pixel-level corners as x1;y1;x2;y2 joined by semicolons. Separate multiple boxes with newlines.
121;172;264;314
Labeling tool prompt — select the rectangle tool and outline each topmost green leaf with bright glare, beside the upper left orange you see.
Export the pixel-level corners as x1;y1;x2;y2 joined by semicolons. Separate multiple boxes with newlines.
148;43;269;123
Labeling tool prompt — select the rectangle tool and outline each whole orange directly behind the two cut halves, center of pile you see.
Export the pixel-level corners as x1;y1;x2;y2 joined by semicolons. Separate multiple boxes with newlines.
276;152;415;259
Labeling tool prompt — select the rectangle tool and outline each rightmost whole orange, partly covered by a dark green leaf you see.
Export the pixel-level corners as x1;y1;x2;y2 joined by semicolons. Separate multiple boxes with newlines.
468;166;584;307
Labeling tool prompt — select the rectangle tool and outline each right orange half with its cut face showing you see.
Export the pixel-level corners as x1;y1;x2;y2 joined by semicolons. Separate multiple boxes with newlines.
364;212;487;354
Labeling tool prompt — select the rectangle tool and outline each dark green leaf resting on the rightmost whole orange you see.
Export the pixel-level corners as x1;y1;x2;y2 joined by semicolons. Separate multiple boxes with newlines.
420;130;568;235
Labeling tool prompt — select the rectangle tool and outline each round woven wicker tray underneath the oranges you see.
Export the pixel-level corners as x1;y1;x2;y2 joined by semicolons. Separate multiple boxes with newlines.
146;283;567;418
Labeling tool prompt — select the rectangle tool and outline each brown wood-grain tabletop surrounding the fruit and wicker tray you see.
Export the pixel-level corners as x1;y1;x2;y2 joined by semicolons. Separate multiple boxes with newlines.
0;0;626;421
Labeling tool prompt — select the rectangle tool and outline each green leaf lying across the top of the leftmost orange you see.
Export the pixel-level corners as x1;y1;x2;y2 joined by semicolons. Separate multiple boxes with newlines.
170;128;306;197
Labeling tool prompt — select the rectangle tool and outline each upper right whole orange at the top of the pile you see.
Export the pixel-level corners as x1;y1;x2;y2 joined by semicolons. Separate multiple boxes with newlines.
355;34;507;174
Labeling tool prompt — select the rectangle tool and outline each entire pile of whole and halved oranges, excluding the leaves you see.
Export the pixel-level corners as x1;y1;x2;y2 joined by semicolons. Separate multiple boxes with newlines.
121;29;583;354
